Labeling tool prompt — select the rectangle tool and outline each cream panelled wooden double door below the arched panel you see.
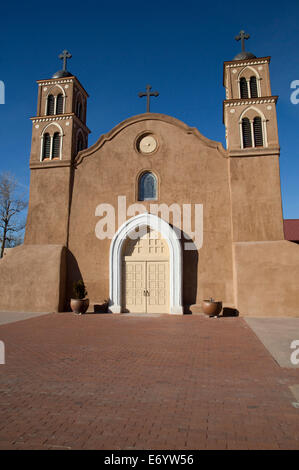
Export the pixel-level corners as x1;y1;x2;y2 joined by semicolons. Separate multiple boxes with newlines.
123;260;169;313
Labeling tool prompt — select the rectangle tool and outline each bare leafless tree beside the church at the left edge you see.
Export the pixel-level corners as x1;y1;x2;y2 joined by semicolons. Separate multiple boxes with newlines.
0;173;28;258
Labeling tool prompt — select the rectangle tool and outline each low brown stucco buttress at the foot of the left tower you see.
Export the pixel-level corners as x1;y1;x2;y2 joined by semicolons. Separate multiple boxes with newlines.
0;245;65;312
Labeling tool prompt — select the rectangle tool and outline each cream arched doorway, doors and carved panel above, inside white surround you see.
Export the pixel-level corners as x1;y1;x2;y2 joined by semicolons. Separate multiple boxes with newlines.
122;226;169;313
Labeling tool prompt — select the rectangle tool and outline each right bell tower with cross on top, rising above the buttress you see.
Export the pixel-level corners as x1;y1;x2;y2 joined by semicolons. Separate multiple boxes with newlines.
223;31;284;242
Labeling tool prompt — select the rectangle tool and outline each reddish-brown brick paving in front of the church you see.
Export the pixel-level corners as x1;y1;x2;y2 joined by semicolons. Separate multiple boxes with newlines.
0;313;299;449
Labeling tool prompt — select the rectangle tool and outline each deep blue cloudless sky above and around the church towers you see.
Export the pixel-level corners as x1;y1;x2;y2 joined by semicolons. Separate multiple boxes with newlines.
0;0;299;218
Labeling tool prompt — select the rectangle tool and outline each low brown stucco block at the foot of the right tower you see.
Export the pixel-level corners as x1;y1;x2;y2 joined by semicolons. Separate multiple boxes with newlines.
234;240;299;317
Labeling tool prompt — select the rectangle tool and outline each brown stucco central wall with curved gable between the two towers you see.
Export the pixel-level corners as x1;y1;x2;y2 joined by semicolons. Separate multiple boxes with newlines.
69;114;237;305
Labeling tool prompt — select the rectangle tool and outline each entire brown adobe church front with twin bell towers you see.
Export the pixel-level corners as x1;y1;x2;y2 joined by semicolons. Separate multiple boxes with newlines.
0;32;299;316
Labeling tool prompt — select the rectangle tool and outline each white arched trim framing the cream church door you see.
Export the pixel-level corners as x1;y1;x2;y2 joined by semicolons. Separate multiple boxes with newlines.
109;212;183;314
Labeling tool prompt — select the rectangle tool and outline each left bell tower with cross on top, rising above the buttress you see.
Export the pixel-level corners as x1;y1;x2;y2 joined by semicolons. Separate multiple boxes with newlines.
25;50;90;246
